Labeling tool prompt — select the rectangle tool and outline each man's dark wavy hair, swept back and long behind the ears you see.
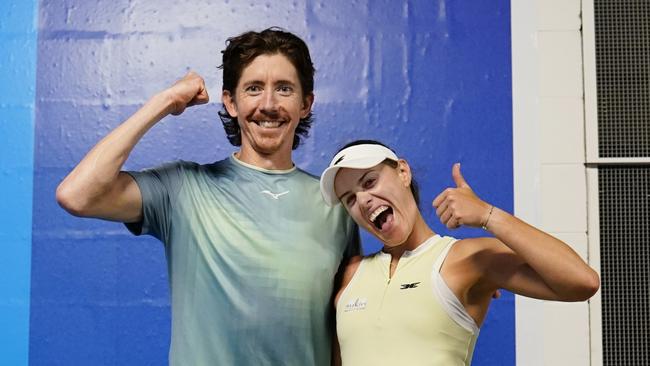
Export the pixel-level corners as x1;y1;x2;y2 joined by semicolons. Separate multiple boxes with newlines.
219;27;315;150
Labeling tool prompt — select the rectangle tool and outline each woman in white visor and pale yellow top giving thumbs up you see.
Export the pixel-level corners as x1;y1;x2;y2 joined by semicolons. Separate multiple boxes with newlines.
320;140;599;365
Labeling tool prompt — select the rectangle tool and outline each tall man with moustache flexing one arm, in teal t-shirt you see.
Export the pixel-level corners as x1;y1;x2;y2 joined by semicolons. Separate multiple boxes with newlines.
57;28;358;365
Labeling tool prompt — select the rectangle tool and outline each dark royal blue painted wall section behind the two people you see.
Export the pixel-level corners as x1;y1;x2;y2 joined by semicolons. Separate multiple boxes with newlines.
29;0;515;365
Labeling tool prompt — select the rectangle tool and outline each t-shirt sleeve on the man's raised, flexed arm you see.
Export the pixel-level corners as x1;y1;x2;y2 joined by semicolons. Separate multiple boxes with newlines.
124;162;182;242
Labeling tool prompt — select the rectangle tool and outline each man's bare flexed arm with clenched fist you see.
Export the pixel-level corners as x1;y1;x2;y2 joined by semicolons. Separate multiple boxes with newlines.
56;72;209;222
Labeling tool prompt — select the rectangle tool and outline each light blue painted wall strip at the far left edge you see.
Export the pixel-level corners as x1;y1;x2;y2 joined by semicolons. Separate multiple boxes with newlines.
0;0;38;365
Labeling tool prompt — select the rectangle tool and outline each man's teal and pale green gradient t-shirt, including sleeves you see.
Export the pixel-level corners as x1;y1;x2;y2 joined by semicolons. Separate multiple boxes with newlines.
127;156;358;366
